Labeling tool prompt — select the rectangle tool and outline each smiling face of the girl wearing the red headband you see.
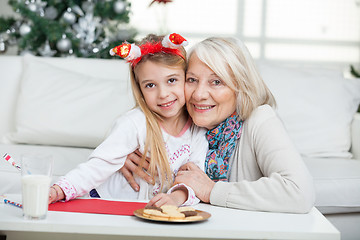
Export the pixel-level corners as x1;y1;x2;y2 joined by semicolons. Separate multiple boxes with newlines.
135;61;185;121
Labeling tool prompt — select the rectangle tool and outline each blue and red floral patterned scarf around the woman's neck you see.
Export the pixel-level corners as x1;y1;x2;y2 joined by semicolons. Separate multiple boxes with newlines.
205;112;243;182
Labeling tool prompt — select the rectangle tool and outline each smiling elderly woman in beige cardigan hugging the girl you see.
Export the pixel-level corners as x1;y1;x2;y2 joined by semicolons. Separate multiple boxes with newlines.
121;38;315;213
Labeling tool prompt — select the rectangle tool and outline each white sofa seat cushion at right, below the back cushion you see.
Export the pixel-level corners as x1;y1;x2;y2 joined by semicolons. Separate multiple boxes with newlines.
304;158;360;214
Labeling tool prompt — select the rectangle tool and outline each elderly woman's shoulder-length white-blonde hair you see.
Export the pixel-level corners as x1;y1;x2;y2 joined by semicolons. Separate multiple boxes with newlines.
188;37;276;120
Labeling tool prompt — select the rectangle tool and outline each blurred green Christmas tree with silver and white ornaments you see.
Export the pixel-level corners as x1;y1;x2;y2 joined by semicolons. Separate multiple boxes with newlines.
0;0;136;58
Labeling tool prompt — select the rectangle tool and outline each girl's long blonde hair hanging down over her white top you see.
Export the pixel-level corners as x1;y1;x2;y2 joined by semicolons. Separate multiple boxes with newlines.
130;34;186;189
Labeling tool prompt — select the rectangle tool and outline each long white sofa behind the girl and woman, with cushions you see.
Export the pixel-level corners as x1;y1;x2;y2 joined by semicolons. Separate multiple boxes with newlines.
0;56;360;239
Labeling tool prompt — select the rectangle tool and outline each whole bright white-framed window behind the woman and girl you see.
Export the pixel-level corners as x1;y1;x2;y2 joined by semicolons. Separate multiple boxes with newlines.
131;0;360;66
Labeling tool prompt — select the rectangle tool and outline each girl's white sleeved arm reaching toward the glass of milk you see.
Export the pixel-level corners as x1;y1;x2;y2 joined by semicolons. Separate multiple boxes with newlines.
51;110;146;201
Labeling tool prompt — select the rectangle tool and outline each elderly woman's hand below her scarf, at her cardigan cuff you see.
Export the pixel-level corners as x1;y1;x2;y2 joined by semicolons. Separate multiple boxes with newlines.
174;162;215;203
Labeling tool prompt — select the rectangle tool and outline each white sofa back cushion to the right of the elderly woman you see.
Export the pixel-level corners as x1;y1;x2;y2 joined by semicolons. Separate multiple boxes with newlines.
258;63;360;158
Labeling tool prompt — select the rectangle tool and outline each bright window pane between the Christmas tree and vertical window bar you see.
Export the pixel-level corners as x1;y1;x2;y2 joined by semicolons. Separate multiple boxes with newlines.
131;0;238;36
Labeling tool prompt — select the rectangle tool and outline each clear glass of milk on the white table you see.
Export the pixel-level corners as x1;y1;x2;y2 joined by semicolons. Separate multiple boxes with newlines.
21;154;54;220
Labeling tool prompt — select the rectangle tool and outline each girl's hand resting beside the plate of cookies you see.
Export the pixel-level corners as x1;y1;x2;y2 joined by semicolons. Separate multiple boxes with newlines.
146;188;187;207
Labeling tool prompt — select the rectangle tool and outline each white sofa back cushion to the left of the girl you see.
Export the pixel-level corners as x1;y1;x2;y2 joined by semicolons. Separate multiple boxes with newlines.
6;56;134;148
